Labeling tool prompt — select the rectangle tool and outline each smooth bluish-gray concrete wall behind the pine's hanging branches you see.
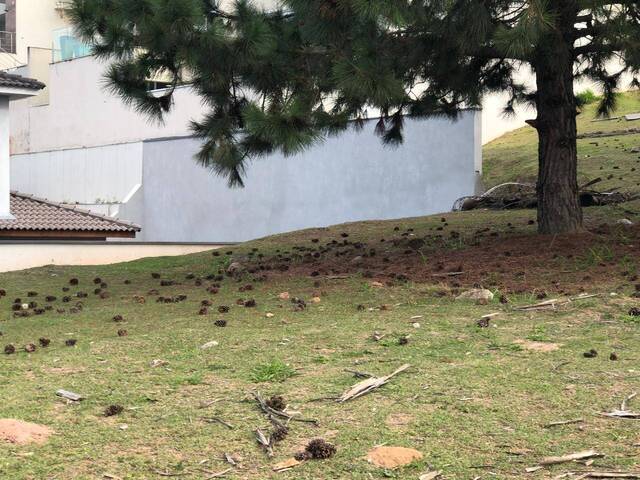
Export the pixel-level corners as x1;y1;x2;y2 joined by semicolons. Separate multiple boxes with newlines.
138;111;482;242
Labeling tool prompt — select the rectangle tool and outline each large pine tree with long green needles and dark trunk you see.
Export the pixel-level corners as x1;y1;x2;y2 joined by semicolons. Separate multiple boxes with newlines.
71;0;640;233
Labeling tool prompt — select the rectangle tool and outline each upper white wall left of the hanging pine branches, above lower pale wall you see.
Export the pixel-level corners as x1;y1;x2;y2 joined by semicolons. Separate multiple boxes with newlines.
11;57;203;154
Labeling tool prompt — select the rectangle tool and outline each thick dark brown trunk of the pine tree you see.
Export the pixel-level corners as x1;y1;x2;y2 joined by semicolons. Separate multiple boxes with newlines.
534;0;582;234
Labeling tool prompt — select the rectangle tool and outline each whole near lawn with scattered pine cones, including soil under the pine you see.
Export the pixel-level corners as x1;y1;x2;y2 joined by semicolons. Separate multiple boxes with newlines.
0;204;640;480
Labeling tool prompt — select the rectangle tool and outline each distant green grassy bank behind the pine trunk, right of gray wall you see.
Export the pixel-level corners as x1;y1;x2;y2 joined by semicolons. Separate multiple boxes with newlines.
484;93;640;191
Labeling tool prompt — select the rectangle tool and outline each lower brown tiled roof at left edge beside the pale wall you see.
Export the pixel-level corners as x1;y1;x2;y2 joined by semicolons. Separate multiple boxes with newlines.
0;192;140;233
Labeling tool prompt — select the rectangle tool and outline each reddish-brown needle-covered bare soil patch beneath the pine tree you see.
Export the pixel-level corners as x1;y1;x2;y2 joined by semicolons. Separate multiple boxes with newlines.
254;225;640;294
